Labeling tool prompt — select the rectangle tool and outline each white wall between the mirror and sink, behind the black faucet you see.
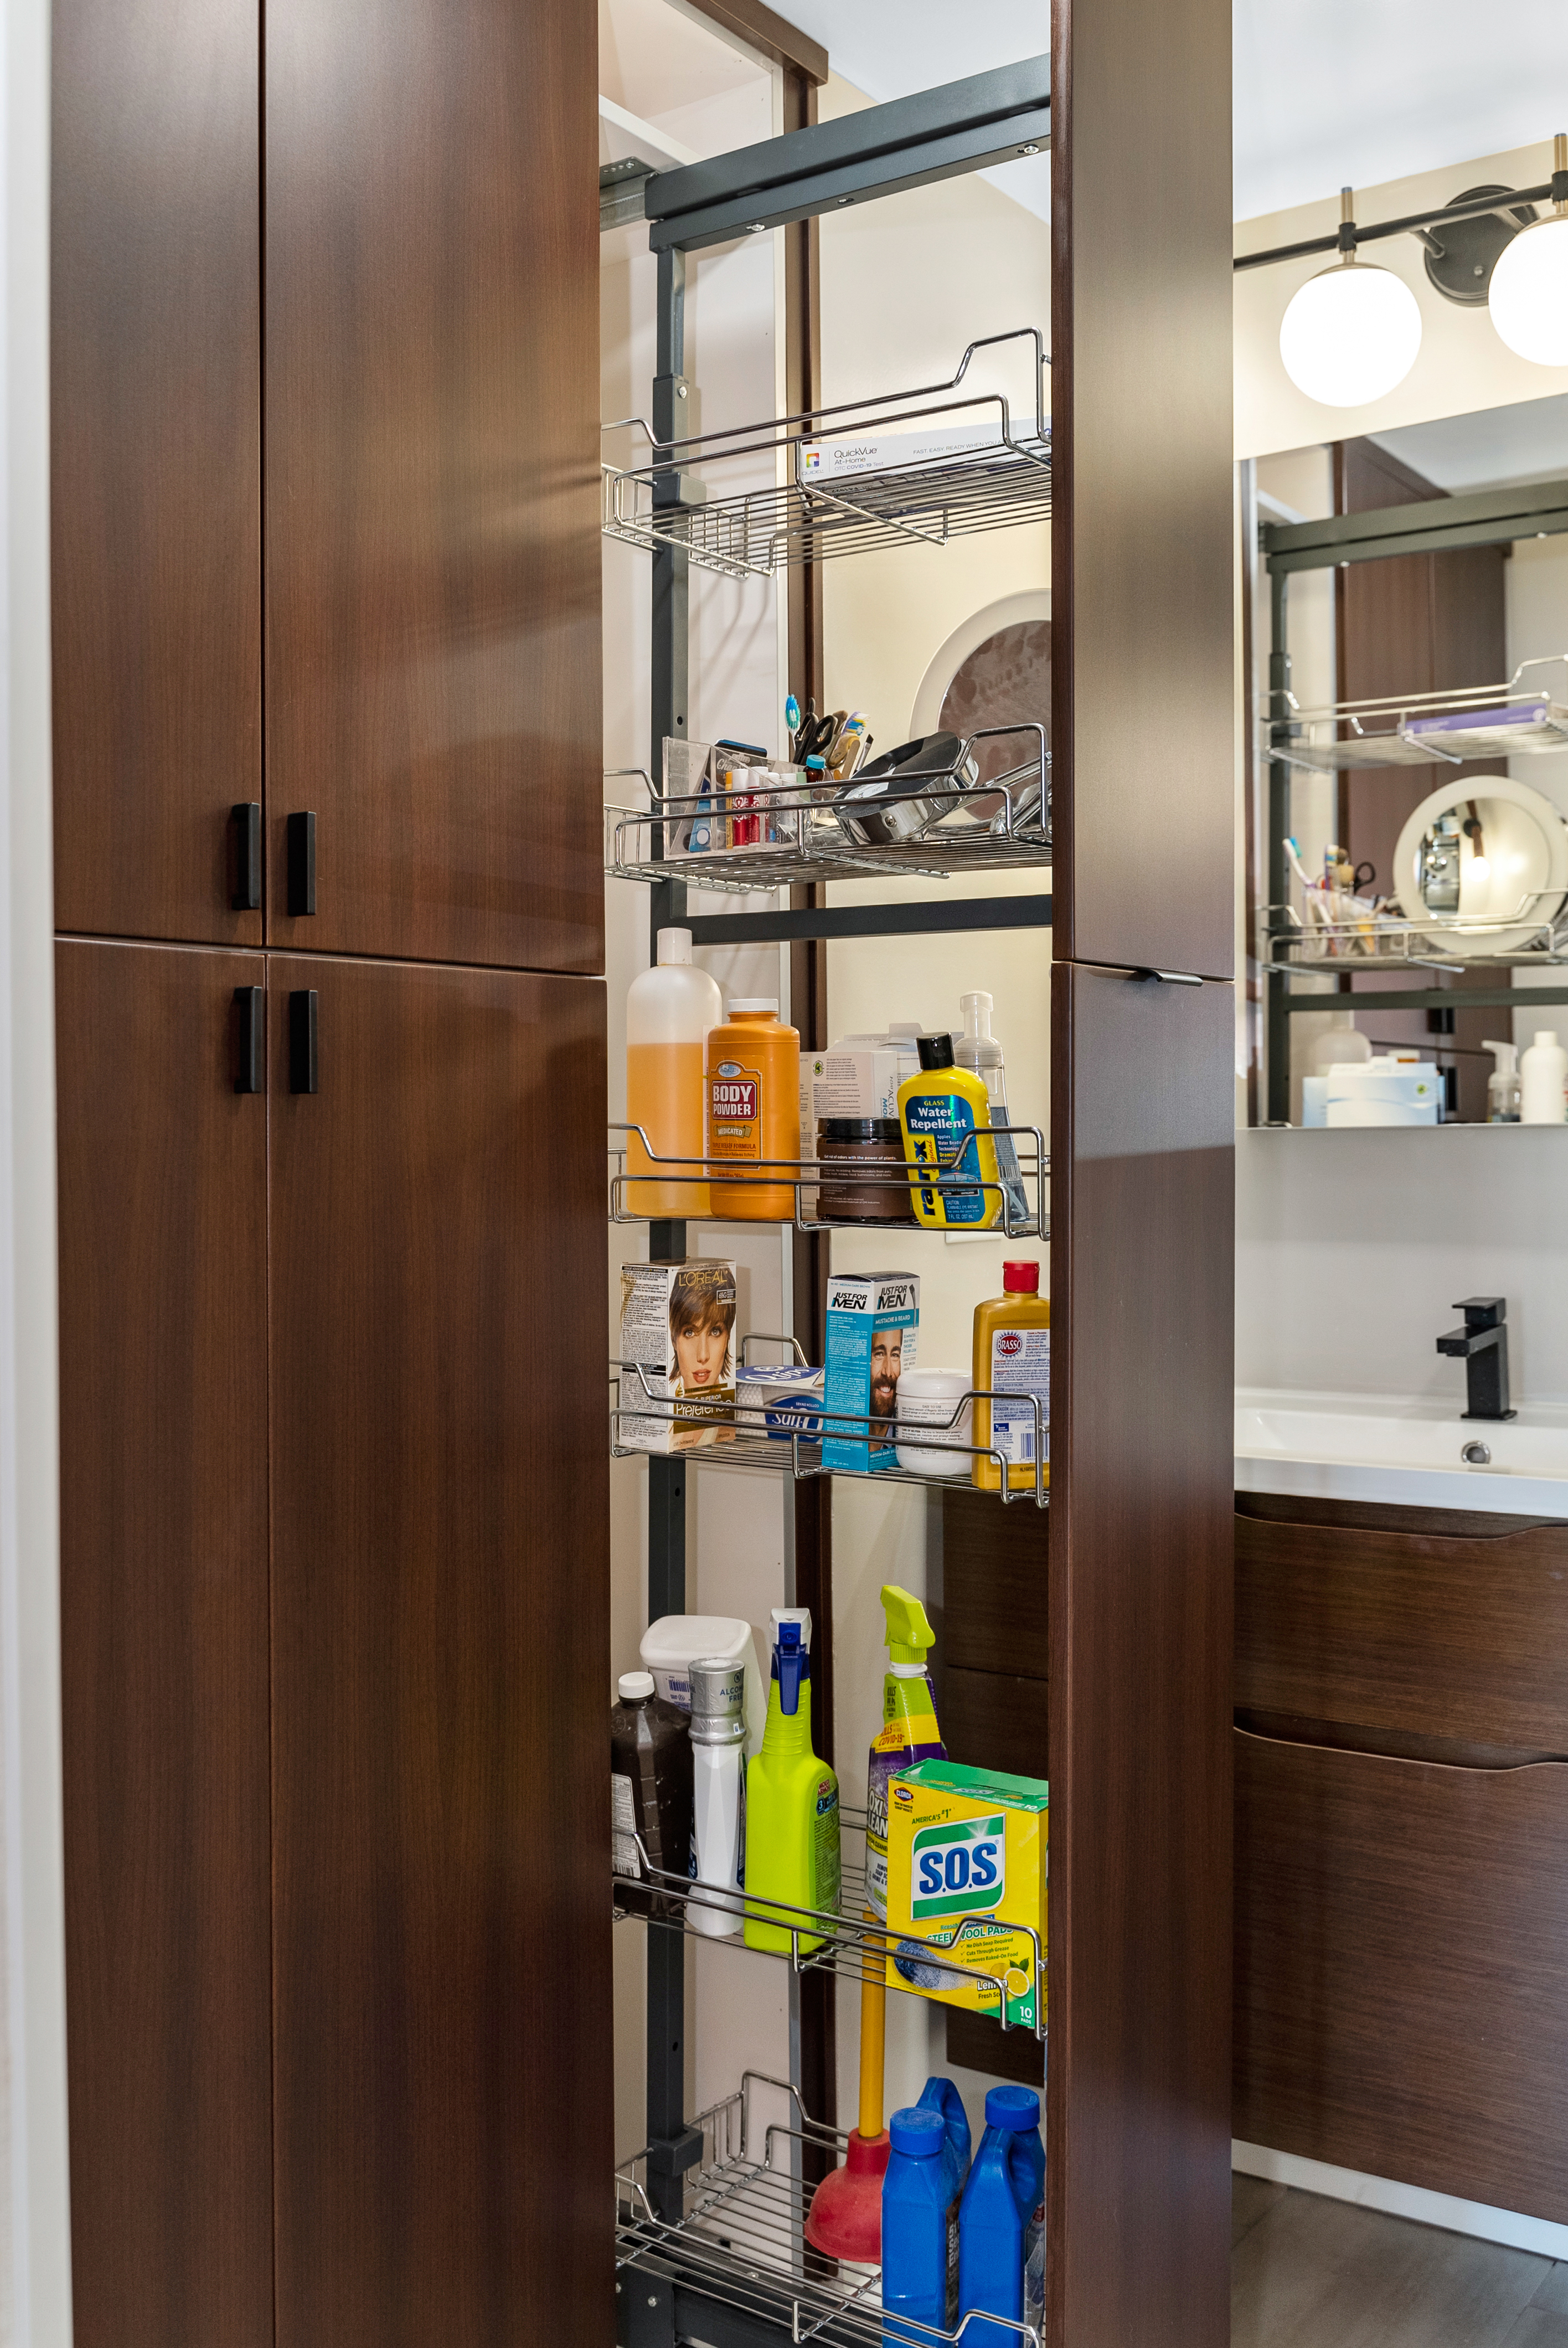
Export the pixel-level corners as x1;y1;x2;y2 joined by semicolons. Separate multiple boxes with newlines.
1237;1125;1568;1411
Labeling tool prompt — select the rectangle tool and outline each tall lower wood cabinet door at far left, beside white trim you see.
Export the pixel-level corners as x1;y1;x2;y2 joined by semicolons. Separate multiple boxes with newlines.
56;941;272;2348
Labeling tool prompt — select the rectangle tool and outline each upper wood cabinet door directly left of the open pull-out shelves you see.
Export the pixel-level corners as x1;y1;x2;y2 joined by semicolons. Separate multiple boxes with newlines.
265;0;604;972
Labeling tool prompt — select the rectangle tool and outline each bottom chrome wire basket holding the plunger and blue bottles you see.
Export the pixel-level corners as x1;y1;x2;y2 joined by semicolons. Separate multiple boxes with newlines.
615;2071;1040;2348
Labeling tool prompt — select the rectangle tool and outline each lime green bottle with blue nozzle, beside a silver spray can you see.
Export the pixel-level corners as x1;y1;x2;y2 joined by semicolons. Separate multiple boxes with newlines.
746;1606;838;1954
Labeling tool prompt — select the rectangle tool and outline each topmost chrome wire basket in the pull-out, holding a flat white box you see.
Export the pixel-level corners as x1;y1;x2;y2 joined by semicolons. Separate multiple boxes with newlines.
604;326;1051;578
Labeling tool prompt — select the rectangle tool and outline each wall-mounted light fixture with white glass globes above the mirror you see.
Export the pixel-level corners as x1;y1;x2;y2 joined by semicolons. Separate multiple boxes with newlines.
1235;131;1568;409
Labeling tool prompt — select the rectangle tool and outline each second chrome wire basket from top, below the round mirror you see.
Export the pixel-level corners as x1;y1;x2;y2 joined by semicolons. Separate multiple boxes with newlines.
606;723;1051;892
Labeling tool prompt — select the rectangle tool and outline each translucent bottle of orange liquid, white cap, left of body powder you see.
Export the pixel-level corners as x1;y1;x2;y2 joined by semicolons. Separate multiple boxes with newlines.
625;930;723;1221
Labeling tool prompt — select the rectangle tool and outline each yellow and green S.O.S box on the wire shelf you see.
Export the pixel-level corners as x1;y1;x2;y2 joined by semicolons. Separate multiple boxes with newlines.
888;1761;1051;2028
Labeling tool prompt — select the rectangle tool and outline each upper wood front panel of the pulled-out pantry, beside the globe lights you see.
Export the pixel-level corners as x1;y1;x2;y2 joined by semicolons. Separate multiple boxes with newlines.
1038;0;1235;981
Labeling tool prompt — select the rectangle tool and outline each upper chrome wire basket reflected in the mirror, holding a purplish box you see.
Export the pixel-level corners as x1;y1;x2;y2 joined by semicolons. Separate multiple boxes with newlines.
1261;653;1568;775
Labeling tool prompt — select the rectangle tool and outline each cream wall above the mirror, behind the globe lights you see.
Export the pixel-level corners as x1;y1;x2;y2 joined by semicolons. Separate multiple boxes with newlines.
1235;142;1568;456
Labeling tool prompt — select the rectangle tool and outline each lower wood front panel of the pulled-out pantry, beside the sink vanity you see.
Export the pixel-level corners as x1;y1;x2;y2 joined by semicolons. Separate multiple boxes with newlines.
1042;962;1235;2348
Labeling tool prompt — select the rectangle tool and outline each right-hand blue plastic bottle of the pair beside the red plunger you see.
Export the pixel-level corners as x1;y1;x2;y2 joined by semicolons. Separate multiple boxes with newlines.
958;2087;1045;2348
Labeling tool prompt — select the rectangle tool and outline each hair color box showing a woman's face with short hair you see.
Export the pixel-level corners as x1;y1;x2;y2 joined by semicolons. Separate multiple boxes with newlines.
620;1256;735;1451
